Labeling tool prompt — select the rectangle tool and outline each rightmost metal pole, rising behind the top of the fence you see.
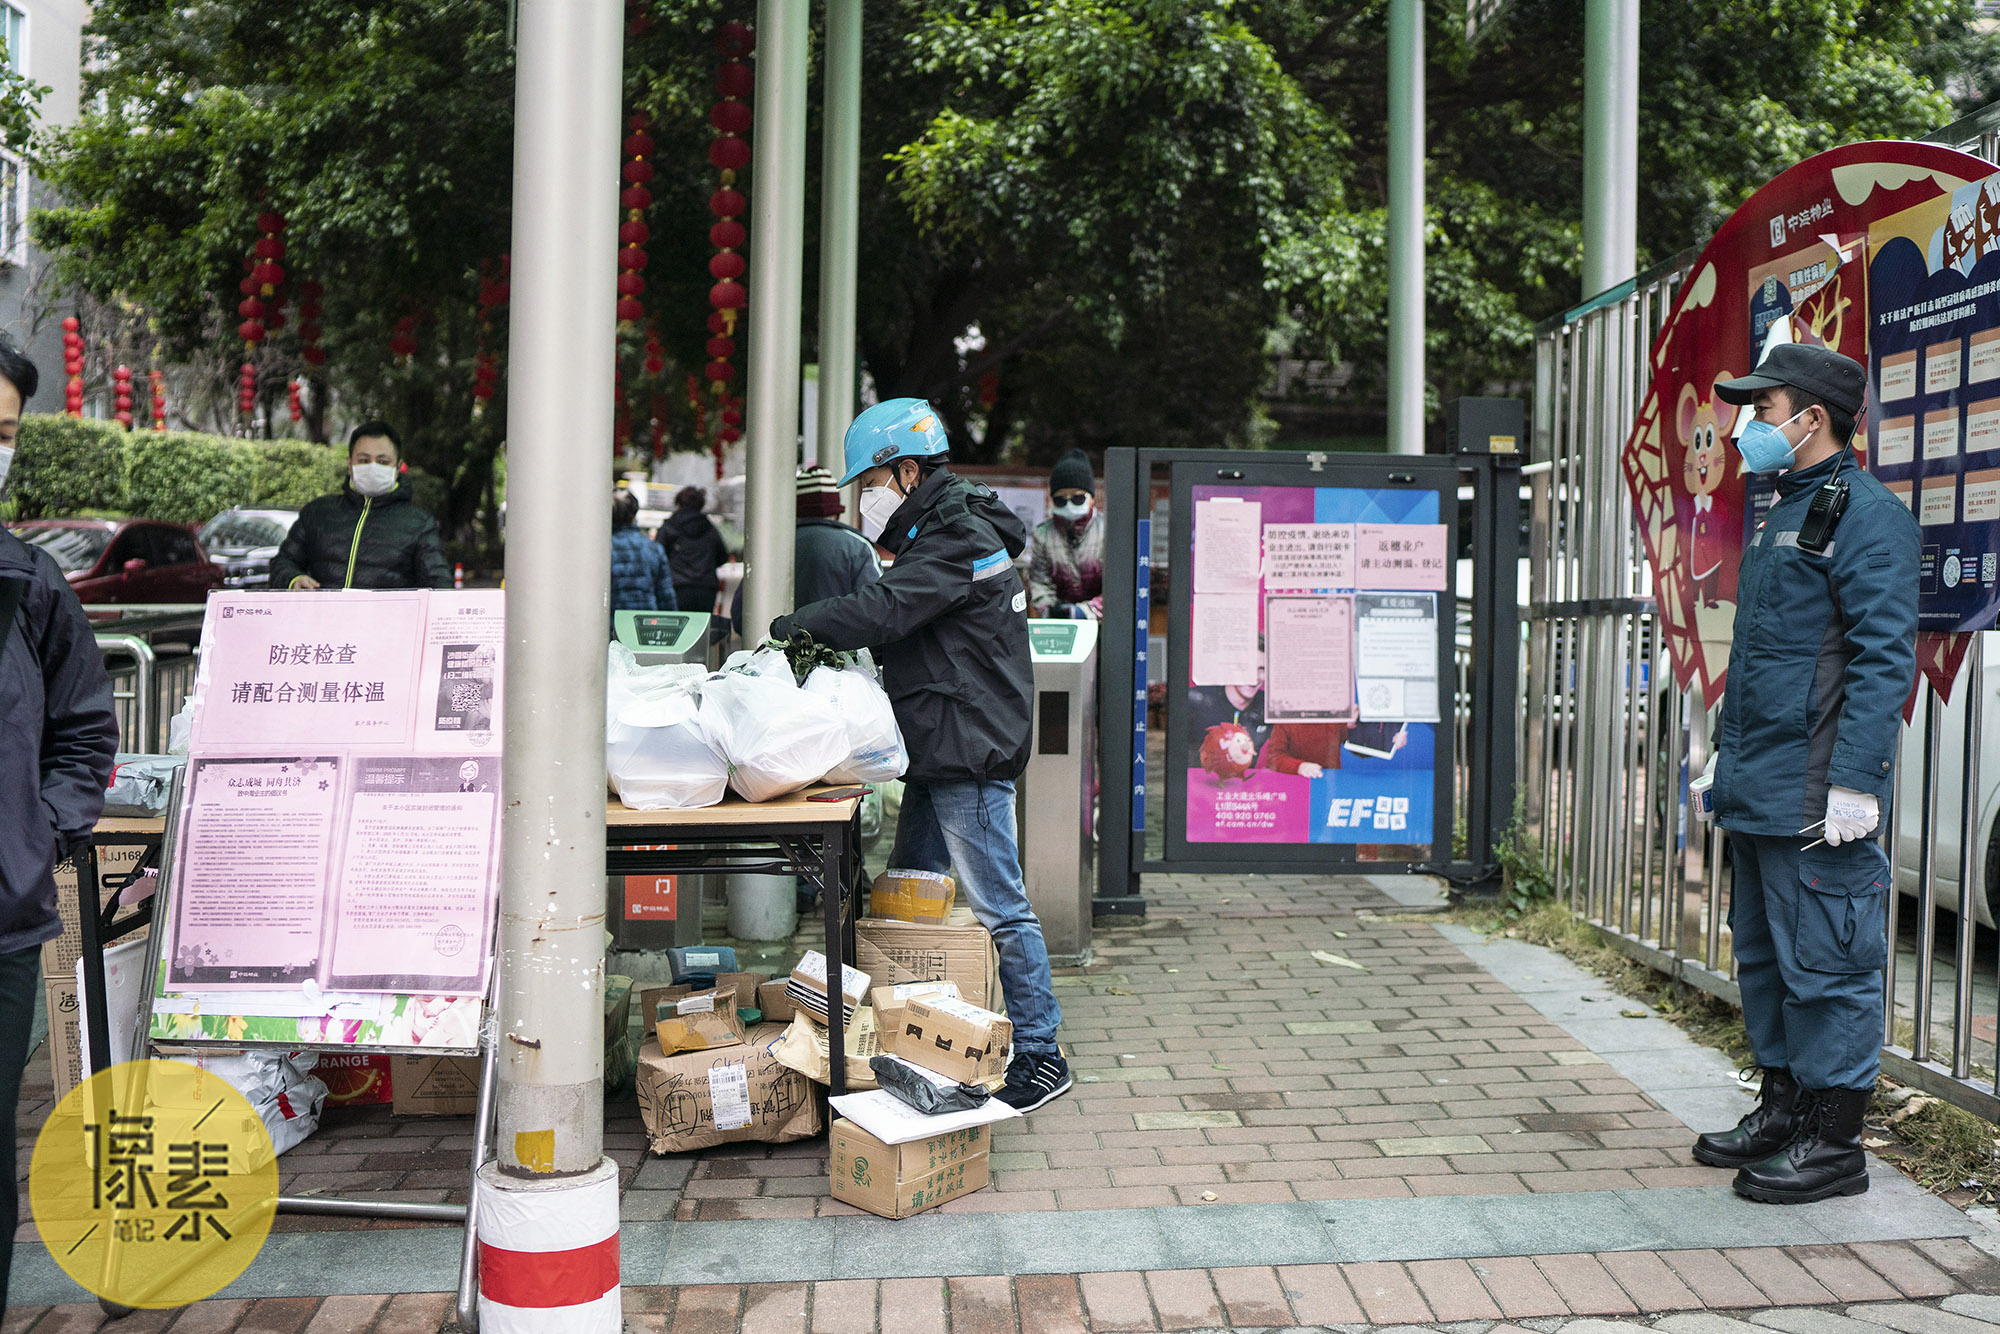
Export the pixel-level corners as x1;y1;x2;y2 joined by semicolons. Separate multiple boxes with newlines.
1584;0;1638;296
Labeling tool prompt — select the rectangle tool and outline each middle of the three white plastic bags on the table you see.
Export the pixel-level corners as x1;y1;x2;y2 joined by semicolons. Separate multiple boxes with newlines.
700;654;848;802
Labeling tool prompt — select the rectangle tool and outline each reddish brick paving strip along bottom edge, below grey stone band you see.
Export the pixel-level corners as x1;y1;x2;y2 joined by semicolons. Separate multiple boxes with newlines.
0;1240;2000;1334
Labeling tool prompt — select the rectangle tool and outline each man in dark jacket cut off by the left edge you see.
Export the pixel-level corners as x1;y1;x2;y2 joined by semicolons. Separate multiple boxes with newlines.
0;342;118;1310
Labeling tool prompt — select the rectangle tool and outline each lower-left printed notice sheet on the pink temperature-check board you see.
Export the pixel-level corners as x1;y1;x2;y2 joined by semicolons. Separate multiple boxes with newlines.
168;758;340;990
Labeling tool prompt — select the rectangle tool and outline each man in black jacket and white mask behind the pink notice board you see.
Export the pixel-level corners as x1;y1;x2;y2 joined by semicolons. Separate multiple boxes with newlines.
270;422;452;588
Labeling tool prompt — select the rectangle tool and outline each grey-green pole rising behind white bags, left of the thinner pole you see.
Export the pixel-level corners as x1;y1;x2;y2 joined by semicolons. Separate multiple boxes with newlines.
744;0;826;646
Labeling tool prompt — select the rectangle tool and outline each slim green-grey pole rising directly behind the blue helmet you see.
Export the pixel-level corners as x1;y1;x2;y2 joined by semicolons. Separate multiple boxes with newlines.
820;0;862;494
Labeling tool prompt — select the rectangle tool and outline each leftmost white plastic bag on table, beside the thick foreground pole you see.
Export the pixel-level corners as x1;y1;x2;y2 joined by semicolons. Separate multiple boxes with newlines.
604;644;730;810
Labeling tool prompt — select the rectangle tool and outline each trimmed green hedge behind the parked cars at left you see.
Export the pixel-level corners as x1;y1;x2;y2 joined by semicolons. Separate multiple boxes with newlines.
6;414;446;524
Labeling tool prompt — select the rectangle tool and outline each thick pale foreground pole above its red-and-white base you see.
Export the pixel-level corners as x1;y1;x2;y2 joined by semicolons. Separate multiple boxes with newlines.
496;0;624;1180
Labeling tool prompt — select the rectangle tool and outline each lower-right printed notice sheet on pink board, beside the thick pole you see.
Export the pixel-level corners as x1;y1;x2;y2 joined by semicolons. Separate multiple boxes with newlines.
328;756;500;996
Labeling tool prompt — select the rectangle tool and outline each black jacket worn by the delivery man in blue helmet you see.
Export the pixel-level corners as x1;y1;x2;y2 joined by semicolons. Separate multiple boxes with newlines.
772;468;1034;782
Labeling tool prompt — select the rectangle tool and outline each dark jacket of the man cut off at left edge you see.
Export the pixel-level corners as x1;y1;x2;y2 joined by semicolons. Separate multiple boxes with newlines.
0;530;118;954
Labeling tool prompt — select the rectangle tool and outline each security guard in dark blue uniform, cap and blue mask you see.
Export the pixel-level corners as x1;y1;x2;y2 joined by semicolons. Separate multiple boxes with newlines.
1694;344;1918;1204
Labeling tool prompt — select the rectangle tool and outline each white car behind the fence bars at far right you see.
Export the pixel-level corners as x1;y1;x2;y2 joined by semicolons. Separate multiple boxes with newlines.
1896;630;2000;926
